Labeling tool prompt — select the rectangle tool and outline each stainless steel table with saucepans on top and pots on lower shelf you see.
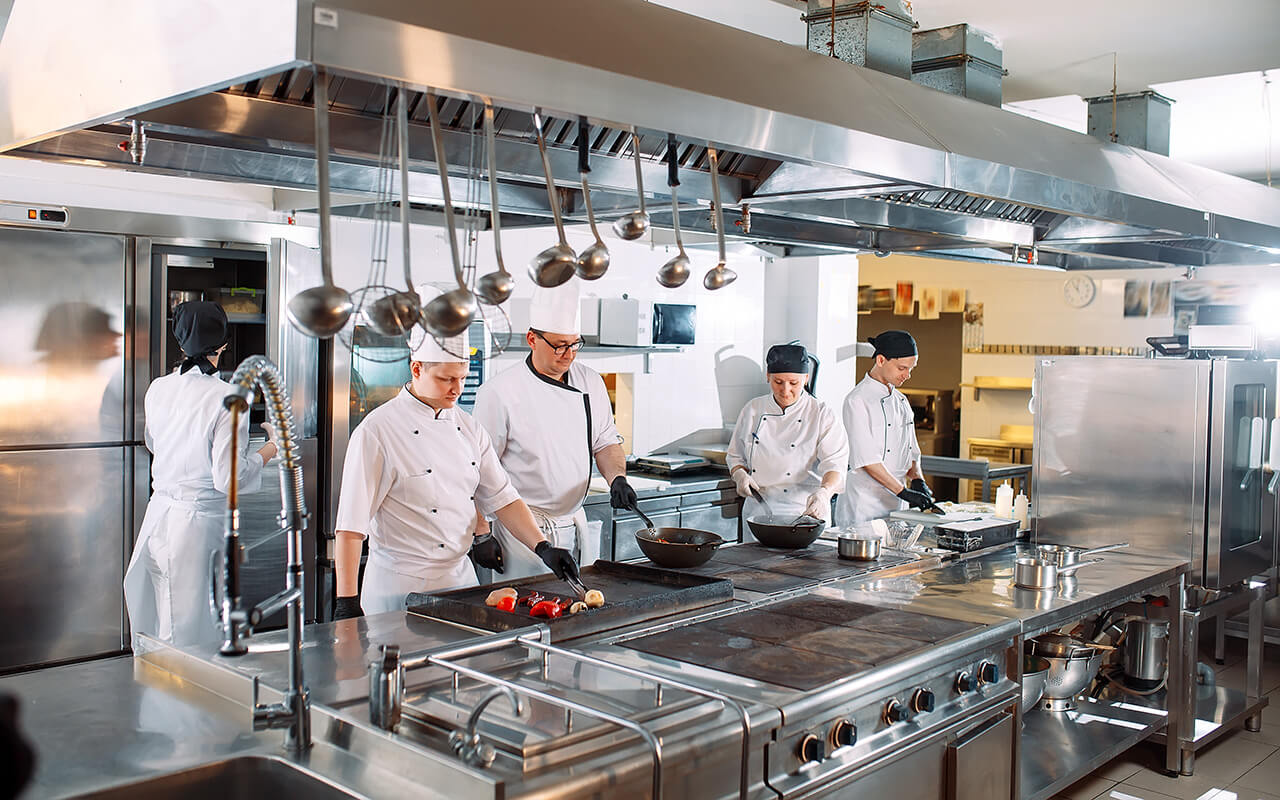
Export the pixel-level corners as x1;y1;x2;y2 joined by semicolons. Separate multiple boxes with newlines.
814;548;1194;800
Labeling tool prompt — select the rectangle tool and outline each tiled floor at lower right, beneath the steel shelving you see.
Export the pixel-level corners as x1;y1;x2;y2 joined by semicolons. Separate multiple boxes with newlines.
1055;628;1280;800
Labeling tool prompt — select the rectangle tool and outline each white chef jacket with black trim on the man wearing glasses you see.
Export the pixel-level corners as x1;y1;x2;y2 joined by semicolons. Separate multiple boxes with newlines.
475;357;622;579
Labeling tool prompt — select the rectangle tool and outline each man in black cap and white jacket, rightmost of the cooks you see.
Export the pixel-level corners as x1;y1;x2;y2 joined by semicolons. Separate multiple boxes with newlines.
836;330;933;527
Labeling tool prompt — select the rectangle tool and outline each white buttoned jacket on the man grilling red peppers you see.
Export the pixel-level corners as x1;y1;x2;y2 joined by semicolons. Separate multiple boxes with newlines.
335;388;520;613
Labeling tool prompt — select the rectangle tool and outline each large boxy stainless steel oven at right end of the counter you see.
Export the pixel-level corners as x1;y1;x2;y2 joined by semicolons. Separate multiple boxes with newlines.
1032;356;1276;589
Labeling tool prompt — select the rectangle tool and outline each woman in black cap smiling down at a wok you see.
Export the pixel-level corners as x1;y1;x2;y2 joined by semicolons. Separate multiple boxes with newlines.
724;343;849;522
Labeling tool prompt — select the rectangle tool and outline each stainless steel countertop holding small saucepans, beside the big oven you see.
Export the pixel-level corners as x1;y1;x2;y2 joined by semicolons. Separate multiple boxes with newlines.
814;545;1190;636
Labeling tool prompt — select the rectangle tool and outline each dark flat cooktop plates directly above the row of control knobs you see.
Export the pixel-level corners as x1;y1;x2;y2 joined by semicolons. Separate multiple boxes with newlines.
620;596;978;691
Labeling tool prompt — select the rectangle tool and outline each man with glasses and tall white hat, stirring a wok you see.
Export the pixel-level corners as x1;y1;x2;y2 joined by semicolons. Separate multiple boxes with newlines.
475;278;636;577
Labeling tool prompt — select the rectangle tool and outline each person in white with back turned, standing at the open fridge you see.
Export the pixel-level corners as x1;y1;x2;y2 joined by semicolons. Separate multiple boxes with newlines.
124;302;276;646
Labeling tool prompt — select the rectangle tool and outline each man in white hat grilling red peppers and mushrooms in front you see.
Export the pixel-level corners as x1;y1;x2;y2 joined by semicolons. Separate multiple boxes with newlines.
334;287;577;620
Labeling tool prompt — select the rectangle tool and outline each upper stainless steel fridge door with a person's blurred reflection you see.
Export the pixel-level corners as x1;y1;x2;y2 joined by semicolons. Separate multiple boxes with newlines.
0;229;125;448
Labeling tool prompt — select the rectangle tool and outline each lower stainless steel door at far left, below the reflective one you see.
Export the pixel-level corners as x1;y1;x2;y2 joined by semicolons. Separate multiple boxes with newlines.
0;447;128;669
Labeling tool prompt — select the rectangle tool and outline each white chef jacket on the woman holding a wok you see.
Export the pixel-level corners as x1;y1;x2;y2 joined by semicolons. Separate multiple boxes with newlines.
724;392;849;520
